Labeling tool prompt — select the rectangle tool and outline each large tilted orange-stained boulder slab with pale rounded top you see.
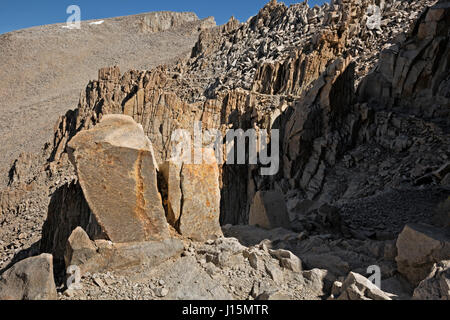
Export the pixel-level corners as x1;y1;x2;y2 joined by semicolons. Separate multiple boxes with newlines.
68;115;169;243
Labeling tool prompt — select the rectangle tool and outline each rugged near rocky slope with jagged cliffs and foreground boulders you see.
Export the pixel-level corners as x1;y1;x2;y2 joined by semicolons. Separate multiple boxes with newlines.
0;0;450;300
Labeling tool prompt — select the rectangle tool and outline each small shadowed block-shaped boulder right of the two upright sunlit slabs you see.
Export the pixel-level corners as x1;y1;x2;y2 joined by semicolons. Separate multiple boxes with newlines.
249;191;290;229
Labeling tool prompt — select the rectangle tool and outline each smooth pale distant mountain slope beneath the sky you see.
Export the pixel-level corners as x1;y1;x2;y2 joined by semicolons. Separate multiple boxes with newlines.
0;12;215;184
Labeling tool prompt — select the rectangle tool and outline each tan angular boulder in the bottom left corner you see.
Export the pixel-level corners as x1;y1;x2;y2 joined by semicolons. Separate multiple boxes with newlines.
0;254;56;300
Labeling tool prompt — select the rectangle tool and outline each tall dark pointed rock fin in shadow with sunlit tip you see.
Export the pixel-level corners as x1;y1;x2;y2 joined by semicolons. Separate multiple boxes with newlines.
283;58;358;199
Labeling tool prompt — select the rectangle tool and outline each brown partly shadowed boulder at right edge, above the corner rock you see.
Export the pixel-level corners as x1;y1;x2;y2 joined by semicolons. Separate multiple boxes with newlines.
395;224;450;284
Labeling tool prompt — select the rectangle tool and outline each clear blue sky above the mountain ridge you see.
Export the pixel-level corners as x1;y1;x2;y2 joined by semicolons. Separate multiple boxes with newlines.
0;0;326;34
